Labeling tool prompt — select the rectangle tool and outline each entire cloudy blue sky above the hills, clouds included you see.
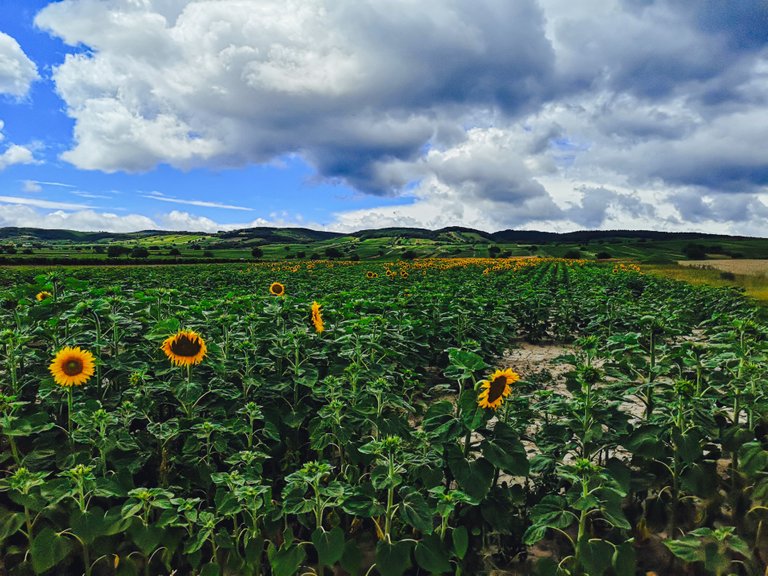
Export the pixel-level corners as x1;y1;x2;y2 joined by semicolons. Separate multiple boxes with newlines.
0;0;768;236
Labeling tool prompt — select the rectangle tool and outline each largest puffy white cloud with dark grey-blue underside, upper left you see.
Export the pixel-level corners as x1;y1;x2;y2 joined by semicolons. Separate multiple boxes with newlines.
36;0;553;180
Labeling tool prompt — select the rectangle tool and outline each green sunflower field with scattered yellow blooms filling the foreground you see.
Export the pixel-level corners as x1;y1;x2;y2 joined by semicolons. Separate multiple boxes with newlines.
0;259;768;576
